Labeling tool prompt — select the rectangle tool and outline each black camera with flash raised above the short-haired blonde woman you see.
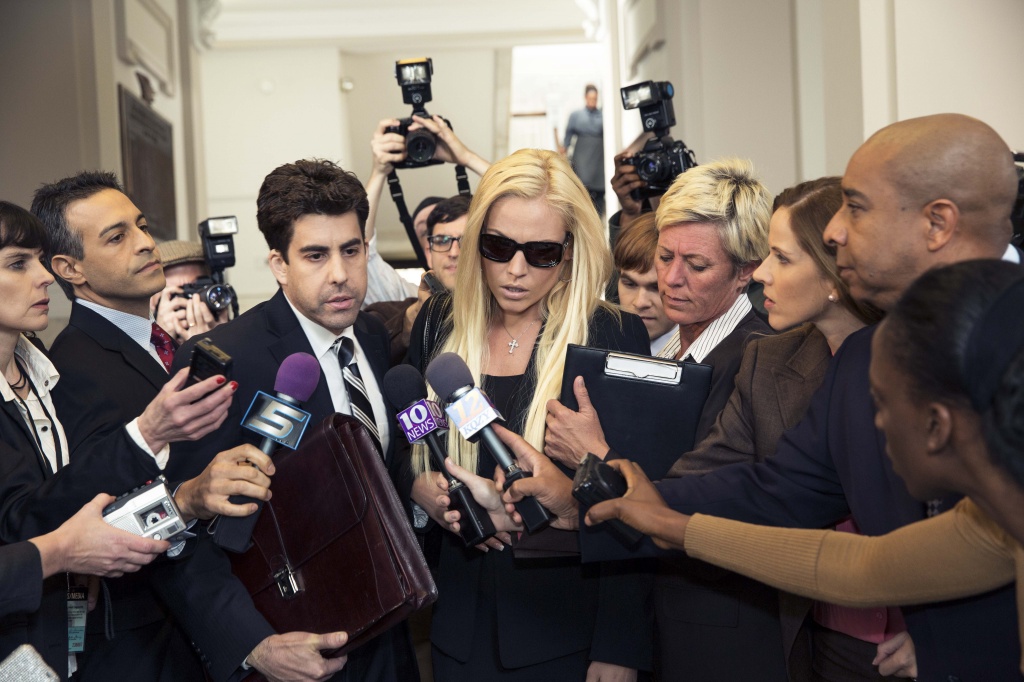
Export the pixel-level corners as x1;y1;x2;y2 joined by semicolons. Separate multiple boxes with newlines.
620;81;697;201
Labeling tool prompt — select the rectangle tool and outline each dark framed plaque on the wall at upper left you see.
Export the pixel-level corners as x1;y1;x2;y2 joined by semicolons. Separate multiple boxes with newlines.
118;85;177;242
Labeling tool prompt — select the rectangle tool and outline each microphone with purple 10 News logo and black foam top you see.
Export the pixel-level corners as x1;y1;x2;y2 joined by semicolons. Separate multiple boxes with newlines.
384;365;495;547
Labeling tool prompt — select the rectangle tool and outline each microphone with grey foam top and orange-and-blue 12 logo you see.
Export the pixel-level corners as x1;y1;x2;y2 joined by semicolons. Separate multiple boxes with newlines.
426;353;553;532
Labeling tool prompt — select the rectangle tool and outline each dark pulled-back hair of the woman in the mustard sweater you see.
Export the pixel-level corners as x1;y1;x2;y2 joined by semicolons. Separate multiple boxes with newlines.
882;260;1024;487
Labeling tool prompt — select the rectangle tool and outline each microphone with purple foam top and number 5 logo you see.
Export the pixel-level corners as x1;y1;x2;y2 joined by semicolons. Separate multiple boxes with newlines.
213;353;321;554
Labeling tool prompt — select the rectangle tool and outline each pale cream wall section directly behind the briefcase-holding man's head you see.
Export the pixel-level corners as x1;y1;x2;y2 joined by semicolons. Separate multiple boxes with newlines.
200;47;351;308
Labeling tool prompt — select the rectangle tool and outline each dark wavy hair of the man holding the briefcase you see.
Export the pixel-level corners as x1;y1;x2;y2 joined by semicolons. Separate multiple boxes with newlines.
256;159;370;262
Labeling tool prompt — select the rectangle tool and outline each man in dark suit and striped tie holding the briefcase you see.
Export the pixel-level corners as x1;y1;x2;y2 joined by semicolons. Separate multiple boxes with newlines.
170;161;419;682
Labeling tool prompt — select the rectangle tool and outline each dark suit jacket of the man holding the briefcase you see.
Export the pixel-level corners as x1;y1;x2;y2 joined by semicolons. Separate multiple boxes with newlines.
167;291;419;682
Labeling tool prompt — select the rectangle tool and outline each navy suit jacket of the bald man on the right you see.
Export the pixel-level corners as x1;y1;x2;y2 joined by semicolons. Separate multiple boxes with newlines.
658;328;1021;682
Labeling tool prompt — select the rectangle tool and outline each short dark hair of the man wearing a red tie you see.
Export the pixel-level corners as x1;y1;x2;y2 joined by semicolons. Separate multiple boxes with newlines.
32;171;124;300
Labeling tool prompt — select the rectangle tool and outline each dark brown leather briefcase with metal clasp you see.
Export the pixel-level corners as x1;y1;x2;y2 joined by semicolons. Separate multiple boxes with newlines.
231;414;437;655
